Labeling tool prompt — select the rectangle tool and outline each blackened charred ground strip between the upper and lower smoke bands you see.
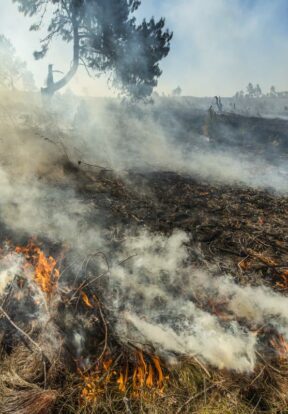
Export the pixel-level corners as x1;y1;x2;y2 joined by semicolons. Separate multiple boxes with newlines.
68;163;288;285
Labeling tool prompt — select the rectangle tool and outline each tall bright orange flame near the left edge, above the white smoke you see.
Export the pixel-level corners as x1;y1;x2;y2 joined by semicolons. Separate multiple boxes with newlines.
15;241;60;294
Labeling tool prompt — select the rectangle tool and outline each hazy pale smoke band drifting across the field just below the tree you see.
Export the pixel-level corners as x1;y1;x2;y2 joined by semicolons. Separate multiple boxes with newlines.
1;90;288;194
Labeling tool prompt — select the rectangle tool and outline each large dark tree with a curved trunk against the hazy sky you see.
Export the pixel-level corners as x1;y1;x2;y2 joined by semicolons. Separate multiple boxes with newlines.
13;0;172;98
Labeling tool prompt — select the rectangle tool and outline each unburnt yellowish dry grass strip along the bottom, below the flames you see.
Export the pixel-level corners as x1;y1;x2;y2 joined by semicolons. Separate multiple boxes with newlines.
0;336;288;414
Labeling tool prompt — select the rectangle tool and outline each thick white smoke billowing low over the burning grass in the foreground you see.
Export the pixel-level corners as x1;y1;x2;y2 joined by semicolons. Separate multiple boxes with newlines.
107;231;288;372
